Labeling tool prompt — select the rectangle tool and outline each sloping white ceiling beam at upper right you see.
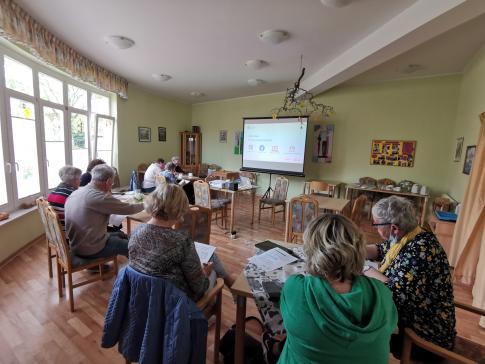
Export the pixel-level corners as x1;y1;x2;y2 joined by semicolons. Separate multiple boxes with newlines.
302;0;485;94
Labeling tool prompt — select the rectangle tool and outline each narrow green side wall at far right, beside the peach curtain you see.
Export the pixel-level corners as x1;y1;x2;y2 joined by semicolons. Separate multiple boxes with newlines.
447;48;485;201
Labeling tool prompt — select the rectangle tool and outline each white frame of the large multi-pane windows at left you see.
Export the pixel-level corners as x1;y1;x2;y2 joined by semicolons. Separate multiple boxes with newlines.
0;42;116;211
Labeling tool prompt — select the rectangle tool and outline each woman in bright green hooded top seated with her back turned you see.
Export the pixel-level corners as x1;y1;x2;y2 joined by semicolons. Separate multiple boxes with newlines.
278;214;397;364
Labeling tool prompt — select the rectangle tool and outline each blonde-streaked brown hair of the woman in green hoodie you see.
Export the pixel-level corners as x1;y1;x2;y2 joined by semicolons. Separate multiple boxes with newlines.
303;214;366;282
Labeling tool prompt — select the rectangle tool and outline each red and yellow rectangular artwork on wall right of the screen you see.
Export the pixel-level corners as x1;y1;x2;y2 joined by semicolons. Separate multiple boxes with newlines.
370;140;416;167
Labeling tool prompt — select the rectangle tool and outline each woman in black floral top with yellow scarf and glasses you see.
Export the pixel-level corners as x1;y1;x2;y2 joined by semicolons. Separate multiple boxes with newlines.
365;196;456;360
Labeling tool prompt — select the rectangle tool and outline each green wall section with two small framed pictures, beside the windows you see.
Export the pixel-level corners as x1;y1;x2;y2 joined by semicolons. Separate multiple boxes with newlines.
117;84;191;185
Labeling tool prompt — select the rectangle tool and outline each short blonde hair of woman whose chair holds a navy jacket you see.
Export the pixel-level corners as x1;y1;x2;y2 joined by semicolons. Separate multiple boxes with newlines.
144;183;189;220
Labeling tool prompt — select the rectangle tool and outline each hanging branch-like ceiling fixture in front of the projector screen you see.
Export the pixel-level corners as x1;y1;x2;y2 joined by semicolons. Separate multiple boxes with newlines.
271;55;334;119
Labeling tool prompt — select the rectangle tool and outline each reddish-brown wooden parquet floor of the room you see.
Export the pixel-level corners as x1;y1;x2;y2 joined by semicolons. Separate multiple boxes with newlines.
0;199;485;363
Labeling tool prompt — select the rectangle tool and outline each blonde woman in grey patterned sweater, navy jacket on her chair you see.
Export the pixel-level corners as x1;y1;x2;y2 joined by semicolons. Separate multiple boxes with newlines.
128;183;233;301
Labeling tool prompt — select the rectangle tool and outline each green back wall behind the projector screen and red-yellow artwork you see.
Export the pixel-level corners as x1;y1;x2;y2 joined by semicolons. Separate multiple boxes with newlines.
192;76;460;196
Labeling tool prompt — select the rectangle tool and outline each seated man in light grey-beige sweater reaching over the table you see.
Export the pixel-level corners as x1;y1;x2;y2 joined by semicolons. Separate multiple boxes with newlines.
65;164;143;259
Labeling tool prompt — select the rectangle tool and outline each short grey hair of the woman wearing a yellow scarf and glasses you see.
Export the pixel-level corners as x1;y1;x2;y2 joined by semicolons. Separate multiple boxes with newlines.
372;196;418;233
